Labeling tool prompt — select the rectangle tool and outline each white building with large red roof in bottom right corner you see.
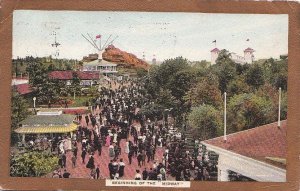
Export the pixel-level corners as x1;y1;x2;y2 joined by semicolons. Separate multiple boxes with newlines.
202;120;287;182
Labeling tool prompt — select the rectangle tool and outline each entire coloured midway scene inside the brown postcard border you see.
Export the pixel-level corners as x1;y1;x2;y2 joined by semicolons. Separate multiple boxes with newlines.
10;10;288;184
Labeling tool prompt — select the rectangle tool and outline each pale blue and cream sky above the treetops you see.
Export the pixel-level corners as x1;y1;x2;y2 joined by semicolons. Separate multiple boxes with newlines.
13;10;288;61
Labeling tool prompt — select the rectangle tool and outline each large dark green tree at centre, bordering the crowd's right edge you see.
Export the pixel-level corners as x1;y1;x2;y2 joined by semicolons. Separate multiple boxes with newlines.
145;57;195;119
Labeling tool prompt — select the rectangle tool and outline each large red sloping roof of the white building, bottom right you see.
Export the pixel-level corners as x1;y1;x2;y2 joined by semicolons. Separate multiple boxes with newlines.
203;120;287;168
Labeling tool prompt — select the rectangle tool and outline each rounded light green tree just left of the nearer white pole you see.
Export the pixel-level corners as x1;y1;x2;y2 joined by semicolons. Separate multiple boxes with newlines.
188;104;222;140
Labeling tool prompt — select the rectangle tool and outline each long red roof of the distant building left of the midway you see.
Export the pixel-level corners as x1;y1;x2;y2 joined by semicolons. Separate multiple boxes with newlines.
48;70;100;80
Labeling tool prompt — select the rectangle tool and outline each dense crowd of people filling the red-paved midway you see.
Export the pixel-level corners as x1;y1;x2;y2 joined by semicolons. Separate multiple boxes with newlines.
17;78;217;181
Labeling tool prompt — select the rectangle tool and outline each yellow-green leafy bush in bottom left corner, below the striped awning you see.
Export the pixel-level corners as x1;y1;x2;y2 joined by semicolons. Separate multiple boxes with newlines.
10;151;58;177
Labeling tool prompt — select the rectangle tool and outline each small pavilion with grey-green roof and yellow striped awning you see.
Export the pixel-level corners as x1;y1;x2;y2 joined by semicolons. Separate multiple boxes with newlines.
15;110;78;142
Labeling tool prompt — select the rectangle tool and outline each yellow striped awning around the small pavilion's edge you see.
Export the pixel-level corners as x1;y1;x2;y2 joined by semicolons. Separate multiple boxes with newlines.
15;123;78;134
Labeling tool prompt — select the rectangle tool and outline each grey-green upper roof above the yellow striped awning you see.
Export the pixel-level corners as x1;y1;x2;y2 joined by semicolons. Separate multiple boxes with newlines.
19;114;75;126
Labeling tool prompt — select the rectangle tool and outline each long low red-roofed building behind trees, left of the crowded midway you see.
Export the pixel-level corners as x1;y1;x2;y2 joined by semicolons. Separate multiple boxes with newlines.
48;70;101;86
